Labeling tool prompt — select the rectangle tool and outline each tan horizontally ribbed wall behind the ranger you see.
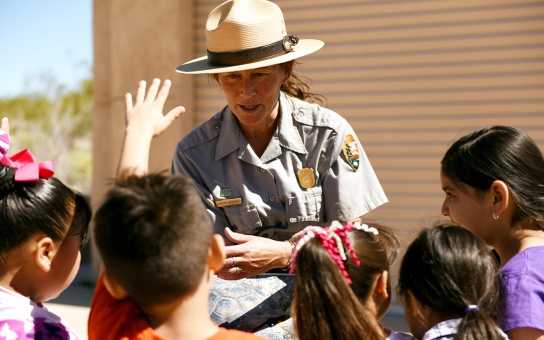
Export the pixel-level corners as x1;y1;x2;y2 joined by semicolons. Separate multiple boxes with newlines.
189;0;544;247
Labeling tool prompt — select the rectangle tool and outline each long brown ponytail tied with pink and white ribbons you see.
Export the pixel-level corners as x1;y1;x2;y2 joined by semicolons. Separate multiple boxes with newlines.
291;224;384;340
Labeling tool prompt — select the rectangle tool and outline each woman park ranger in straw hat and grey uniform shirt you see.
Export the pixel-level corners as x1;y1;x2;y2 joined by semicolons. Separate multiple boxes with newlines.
172;0;387;280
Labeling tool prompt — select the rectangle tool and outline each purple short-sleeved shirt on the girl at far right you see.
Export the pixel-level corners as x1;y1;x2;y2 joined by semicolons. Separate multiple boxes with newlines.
499;246;544;332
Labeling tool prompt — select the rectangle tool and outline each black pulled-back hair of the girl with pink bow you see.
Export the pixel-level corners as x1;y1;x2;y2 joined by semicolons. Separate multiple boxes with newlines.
0;165;91;261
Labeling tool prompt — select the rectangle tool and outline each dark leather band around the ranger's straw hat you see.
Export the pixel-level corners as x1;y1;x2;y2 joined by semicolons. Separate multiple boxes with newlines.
207;35;299;66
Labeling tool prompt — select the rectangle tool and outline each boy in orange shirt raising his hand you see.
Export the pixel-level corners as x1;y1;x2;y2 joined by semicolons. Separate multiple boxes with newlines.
88;79;261;340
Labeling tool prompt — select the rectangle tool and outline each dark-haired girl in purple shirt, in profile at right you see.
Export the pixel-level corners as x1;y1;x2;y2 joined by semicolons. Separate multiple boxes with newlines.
440;126;544;340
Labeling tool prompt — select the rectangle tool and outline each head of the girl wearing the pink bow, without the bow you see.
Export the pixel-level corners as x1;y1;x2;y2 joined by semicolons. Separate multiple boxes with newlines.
0;164;91;302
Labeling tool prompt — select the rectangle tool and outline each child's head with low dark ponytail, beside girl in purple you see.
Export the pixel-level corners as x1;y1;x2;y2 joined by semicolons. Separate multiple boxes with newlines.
398;222;502;339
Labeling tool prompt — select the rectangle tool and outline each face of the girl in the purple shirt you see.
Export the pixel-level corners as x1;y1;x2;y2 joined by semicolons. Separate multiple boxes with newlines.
440;171;495;244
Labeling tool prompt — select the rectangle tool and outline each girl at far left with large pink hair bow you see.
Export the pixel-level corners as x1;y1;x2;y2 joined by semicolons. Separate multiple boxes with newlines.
0;118;91;339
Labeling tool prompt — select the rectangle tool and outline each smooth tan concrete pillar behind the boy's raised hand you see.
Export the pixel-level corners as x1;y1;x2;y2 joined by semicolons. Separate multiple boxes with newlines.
91;0;194;278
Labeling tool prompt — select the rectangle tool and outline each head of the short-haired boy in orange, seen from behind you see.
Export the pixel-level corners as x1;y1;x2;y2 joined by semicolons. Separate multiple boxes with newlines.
94;173;223;307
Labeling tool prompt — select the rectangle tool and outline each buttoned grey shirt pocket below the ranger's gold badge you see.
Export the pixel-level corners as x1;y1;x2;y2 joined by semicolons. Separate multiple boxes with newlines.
288;187;323;223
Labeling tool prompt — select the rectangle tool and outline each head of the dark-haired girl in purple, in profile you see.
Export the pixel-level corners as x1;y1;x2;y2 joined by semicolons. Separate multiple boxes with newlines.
441;126;544;239
